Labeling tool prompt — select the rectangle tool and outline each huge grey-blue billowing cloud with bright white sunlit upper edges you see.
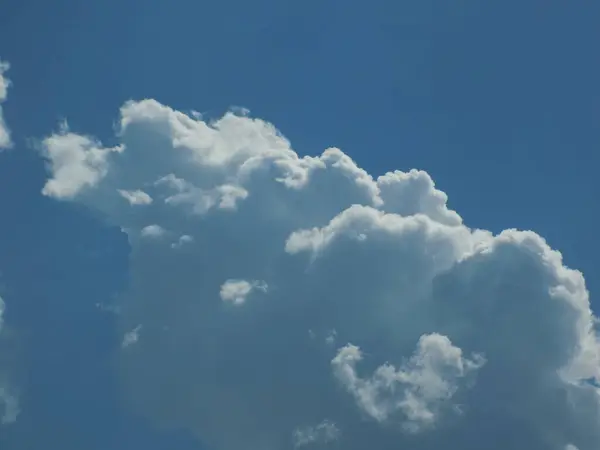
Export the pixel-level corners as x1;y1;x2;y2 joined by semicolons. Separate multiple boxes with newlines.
43;100;600;450
